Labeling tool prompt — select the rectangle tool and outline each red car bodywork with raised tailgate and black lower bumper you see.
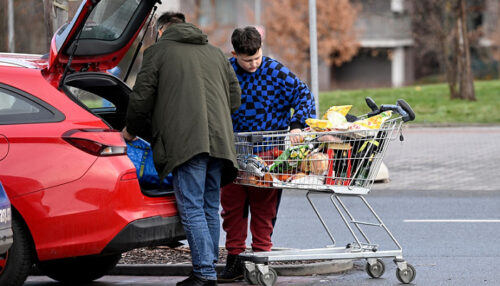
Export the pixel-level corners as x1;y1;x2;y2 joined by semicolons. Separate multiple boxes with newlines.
0;0;184;275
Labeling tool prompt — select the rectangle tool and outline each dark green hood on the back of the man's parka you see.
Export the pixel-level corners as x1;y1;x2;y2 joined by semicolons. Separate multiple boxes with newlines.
161;23;208;45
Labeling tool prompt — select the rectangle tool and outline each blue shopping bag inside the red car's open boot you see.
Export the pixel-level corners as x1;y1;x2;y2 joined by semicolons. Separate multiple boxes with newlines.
127;138;172;186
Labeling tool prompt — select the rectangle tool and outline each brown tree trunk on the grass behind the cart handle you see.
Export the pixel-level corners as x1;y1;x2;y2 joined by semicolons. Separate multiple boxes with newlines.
458;0;476;101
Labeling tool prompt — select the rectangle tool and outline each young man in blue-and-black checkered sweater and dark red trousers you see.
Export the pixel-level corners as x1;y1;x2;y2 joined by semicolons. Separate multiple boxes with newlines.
217;27;316;283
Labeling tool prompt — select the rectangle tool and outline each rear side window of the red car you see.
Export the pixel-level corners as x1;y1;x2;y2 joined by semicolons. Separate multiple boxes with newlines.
0;89;56;125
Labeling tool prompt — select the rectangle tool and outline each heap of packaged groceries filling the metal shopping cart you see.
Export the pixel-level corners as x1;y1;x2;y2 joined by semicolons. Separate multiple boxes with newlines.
234;100;402;189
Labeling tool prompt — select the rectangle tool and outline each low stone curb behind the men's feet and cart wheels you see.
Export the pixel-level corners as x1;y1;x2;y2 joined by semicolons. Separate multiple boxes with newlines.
108;260;353;276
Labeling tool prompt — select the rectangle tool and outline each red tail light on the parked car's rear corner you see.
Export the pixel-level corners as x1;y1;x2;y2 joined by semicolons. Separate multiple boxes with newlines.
62;129;127;156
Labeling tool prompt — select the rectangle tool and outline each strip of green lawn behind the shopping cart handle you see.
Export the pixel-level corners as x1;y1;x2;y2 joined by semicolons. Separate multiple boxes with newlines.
320;80;500;124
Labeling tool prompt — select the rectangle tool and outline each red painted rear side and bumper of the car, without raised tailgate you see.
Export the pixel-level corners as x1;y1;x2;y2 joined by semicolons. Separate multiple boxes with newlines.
0;67;183;260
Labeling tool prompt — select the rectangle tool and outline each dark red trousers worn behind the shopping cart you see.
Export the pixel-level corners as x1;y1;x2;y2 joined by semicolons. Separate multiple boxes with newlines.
221;184;282;255
